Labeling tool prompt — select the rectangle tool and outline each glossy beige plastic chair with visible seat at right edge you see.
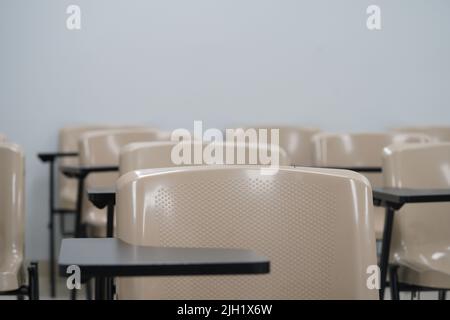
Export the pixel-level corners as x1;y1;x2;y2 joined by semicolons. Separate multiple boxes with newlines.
383;143;450;289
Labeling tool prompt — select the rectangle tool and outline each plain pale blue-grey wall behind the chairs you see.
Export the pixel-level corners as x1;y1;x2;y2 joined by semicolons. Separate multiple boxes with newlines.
0;0;450;259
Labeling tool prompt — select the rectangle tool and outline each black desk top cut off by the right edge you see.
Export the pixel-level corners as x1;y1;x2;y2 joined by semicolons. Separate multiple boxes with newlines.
373;188;450;204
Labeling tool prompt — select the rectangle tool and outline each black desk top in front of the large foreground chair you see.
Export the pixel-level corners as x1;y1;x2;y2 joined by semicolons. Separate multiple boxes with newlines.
58;238;270;277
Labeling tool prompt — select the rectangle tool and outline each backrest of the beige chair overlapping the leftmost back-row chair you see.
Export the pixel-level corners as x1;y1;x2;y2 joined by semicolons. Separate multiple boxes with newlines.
79;128;165;222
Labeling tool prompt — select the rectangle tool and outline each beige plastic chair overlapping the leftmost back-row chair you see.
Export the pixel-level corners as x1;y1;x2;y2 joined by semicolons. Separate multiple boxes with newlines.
79;128;165;236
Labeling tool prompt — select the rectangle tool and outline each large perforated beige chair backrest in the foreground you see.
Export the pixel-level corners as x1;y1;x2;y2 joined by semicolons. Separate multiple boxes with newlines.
116;166;378;299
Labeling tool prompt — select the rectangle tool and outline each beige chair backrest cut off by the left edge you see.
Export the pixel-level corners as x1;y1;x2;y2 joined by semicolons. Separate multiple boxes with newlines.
0;142;25;291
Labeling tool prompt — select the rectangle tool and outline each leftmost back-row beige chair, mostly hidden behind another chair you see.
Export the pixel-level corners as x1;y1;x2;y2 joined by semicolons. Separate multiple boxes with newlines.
58;125;147;208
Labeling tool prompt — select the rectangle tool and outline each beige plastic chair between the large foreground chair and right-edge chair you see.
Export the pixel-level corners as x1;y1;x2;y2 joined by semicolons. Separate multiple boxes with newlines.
313;133;431;239
